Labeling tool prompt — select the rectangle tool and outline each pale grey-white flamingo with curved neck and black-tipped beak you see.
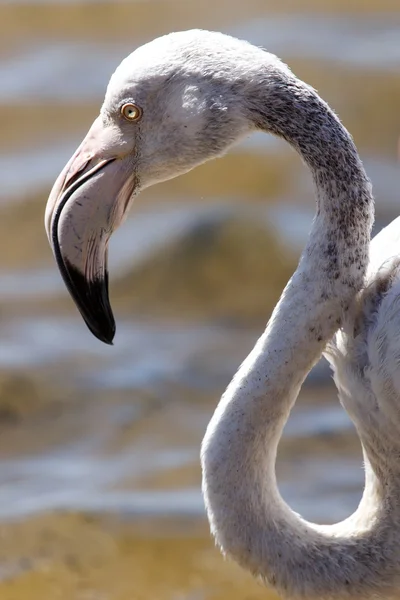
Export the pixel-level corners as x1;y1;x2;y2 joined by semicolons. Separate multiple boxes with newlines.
45;30;400;600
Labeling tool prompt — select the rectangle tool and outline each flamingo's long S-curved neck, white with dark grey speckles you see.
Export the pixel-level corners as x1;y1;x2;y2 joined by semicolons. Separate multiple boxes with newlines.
202;72;400;600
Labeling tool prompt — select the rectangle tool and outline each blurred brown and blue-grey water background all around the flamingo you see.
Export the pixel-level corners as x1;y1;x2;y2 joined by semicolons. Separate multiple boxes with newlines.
0;0;400;600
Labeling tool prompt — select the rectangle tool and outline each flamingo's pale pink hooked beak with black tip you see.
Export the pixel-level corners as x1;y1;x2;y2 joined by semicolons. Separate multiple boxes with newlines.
45;117;138;344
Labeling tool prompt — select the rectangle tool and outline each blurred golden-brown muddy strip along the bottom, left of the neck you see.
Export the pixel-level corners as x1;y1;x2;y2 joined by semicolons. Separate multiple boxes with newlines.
0;514;277;600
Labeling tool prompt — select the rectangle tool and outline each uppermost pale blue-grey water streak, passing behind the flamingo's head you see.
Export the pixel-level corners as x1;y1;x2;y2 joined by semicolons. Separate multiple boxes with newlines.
0;14;400;102
